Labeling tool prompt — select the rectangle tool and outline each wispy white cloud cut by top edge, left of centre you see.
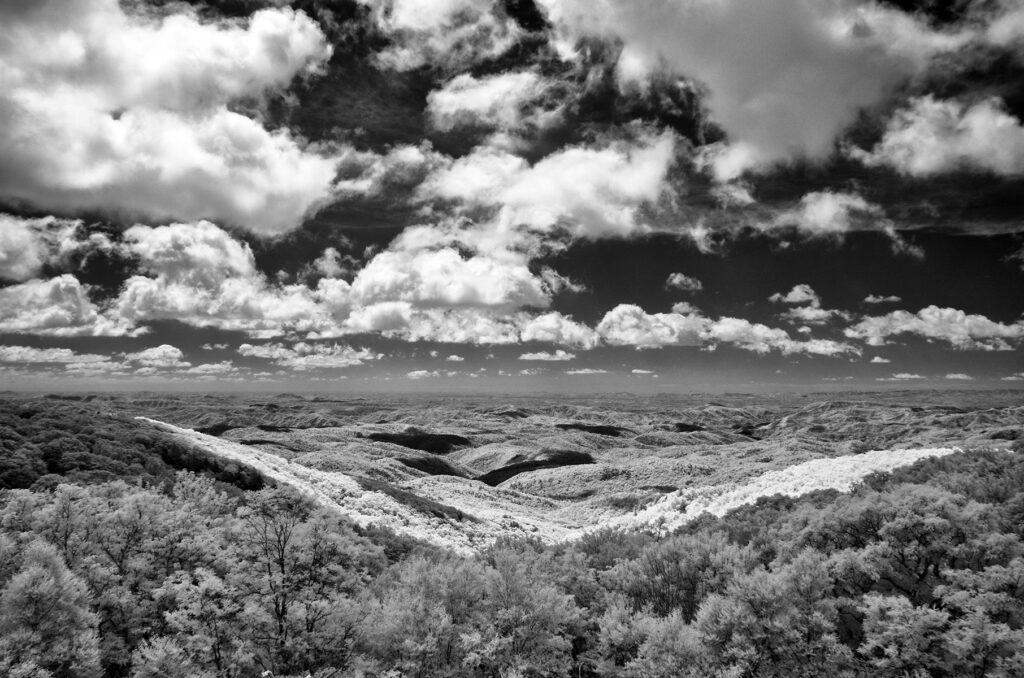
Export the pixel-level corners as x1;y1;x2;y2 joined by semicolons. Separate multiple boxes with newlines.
359;0;520;71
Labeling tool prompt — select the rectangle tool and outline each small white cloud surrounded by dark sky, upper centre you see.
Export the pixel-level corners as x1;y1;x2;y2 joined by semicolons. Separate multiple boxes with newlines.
427;71;557;131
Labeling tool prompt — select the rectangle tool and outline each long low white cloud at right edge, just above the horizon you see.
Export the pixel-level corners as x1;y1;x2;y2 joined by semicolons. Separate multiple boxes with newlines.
844;305;1024;350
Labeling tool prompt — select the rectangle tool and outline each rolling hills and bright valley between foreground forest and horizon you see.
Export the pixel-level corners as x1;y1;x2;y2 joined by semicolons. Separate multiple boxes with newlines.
8;391;1024;550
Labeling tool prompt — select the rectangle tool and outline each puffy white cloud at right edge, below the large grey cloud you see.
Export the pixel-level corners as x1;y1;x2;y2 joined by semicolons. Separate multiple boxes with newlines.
851;96;1024;176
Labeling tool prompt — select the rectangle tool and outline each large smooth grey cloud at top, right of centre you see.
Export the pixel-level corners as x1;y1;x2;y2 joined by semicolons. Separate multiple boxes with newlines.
540;0;965;178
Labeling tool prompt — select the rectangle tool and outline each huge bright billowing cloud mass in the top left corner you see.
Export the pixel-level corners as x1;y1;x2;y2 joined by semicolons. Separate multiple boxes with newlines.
0;0;338;235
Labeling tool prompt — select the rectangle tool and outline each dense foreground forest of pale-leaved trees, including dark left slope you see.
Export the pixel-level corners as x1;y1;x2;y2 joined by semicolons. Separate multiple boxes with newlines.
0;407;1024;678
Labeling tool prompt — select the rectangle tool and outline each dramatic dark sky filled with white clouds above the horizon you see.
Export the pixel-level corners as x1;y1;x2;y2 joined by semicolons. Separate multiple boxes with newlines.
0;0;1024;393
